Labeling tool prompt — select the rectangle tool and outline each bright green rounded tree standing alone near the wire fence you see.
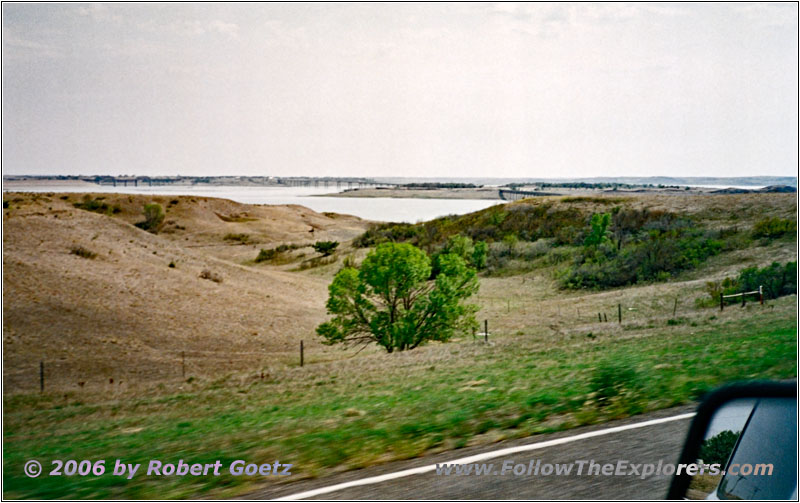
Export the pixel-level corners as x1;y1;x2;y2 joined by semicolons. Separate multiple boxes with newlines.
317;243;478;353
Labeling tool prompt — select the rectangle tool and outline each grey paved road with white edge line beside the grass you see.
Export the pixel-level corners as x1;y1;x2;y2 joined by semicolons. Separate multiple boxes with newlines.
246;406;695;500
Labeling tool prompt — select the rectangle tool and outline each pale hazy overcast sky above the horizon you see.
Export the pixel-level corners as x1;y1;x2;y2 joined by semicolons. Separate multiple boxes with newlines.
2;3;798;178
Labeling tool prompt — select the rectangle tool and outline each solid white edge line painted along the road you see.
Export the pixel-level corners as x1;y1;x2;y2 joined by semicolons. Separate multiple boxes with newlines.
276;412;695;501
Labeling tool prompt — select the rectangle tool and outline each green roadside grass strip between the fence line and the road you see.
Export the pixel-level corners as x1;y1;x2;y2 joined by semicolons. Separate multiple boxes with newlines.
3;296;797;499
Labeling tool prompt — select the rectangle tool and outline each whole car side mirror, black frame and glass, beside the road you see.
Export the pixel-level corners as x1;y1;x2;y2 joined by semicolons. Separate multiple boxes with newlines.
667;382;797;500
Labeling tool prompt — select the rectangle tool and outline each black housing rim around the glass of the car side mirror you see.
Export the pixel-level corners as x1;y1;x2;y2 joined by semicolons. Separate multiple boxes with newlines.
667;382;797;500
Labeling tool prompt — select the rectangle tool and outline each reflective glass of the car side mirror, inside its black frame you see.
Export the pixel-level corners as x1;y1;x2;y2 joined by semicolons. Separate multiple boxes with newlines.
686;398;797;500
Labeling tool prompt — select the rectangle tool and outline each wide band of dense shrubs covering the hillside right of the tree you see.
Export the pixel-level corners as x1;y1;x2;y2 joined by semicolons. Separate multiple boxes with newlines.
354;198;796;289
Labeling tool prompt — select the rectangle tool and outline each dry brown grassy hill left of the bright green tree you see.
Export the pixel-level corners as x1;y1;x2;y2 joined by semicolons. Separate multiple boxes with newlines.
3;193;366;392
